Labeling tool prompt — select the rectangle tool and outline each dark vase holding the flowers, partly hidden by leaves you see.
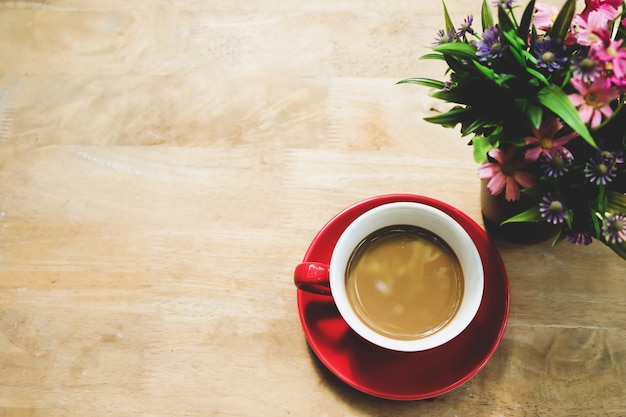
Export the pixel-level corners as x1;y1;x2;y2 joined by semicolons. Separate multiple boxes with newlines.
480;180;560;243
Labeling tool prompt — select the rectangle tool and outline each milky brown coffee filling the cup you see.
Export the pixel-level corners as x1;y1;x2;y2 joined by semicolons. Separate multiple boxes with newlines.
346;225;464;340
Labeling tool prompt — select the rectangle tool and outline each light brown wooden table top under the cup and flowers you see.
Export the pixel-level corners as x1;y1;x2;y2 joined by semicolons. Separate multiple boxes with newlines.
0;0;626;417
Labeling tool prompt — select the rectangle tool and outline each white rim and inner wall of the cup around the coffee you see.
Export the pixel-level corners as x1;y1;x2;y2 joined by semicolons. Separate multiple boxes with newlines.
330;202;484;352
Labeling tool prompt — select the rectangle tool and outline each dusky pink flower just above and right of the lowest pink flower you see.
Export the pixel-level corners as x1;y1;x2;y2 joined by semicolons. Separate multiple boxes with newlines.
524;117;578;162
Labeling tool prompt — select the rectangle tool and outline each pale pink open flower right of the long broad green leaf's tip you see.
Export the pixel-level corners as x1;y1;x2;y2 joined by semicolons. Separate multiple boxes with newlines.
568;78;619;127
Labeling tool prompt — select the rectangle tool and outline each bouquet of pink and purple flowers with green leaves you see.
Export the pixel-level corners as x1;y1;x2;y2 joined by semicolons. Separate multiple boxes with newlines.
400;0;626;259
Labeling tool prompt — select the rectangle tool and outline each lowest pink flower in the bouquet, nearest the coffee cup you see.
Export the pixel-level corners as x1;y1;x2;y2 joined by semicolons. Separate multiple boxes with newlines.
478;147;535;201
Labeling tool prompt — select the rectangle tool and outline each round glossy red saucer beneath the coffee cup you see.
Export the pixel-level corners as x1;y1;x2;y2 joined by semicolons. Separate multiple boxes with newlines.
297;194;510;400
